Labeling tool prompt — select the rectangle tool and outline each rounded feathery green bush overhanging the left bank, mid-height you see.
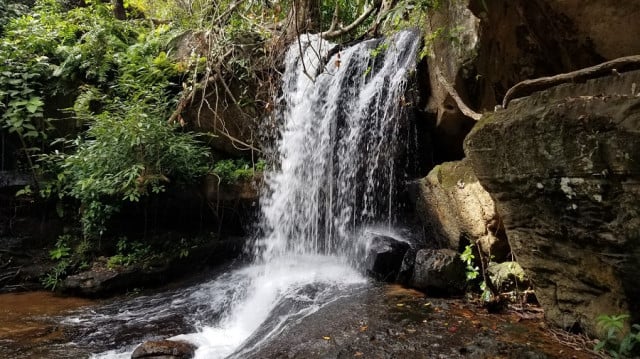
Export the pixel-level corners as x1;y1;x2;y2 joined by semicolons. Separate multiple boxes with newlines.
53;98;209;238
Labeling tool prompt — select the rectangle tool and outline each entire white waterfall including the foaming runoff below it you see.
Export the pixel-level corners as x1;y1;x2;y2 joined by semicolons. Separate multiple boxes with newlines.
84;31;419;359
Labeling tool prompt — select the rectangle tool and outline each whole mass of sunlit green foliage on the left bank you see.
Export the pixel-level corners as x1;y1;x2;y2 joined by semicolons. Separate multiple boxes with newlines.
0;0;208;238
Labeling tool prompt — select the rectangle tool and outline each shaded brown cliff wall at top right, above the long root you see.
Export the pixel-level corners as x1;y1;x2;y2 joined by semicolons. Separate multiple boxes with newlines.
424;0;640;160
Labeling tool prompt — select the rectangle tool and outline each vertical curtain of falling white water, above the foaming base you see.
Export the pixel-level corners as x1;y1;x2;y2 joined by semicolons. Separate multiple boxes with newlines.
260;31;419;262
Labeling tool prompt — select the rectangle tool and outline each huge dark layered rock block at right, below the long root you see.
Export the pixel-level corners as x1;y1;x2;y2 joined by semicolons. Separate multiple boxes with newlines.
465;71;640;334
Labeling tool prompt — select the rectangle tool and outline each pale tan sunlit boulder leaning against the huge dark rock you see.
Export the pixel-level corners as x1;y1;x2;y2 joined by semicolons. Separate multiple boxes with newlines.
416;160;510;261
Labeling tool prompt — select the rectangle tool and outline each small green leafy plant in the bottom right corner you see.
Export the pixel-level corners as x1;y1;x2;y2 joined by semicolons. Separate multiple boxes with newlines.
593;314;640;358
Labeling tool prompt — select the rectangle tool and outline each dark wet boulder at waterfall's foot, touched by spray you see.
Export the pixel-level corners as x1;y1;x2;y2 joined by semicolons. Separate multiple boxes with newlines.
365;235;411;281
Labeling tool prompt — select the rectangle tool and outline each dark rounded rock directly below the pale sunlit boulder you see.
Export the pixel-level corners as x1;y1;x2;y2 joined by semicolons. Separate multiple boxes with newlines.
410;249;467;295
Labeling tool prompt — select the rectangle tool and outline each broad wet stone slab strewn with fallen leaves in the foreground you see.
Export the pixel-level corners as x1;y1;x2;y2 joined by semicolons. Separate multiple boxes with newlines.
246;285;596;359
